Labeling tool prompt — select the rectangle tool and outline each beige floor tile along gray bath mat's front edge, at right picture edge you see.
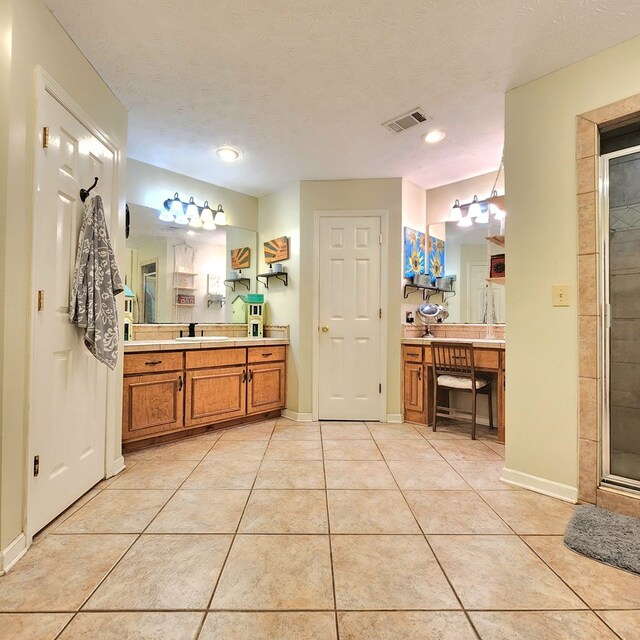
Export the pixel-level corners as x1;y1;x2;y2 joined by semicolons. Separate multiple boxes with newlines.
524;536;640;609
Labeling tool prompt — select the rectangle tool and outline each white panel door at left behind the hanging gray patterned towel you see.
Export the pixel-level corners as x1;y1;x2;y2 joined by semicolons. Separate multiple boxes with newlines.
28;93;117;534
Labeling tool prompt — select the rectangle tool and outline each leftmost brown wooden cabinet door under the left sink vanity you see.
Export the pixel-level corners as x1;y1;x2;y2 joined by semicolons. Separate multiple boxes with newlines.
122;372;184;442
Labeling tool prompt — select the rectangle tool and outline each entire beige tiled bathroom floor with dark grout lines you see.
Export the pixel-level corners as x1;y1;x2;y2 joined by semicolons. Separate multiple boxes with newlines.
0;419;640;640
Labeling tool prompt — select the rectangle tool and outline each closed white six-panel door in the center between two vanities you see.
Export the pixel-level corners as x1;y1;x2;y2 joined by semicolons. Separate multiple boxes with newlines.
318;217;381;420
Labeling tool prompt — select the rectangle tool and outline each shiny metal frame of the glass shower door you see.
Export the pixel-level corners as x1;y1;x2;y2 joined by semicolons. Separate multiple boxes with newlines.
597;145;640;492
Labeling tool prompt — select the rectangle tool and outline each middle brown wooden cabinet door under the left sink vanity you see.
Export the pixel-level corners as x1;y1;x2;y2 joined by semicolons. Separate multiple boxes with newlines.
185;366;247;427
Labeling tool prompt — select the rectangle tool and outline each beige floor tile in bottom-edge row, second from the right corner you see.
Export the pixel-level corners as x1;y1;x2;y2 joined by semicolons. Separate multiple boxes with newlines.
469;611;616;640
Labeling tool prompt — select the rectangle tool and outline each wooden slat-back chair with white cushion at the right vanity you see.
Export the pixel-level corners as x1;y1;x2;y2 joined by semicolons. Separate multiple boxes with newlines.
431;342;493;440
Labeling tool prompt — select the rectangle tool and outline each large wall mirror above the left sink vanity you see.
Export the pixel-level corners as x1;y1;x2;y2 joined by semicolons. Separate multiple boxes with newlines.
125;203;258;324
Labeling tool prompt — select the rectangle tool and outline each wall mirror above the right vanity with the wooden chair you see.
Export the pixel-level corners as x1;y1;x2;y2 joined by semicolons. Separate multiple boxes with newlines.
429;222;505;324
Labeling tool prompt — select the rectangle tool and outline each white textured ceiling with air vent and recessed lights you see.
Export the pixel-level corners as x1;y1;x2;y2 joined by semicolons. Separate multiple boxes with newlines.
45;0;640;195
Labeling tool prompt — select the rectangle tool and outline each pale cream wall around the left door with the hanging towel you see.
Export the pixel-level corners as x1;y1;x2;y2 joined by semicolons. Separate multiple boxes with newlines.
0;0;127;551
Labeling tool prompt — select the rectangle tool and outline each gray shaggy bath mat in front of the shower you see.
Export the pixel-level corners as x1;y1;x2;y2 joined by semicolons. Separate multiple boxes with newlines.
564;505;640;574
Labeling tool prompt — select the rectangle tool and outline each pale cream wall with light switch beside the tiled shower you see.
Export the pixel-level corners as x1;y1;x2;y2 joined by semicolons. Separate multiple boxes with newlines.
505;33;640;496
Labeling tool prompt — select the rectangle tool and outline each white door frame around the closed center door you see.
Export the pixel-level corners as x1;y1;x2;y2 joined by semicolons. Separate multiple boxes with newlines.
311;209;389;422
